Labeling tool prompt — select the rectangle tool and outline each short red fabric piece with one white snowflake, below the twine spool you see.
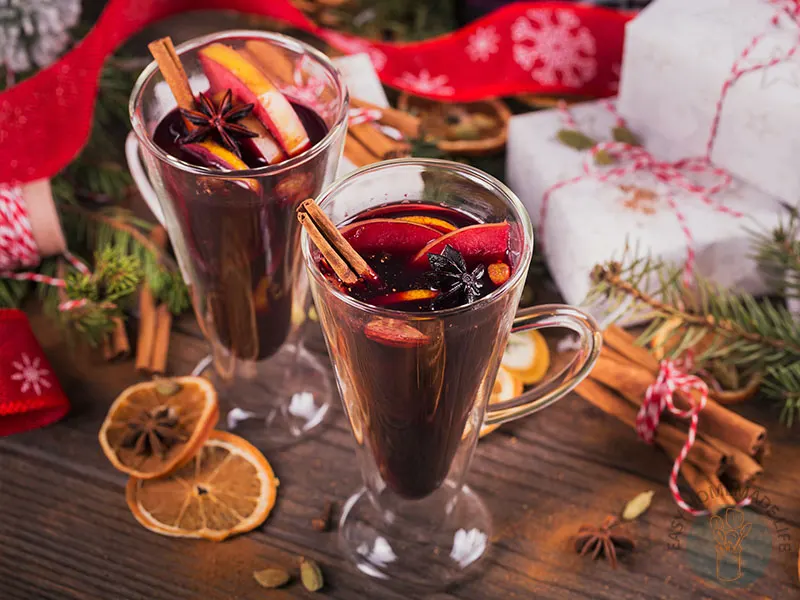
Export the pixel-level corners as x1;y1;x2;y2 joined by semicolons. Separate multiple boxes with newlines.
0;309;69;436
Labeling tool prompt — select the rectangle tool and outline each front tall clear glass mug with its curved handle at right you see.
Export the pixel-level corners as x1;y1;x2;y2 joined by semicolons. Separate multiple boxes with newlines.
302;159;601;587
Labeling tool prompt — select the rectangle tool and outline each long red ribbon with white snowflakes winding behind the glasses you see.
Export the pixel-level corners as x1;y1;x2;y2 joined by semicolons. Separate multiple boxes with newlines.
0;0;630;183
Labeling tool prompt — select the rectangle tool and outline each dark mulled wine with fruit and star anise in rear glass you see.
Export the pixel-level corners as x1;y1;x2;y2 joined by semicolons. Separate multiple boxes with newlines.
153;43;334;360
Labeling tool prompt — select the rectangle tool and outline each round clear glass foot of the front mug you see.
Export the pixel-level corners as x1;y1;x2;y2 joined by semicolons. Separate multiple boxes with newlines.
339;486;492;591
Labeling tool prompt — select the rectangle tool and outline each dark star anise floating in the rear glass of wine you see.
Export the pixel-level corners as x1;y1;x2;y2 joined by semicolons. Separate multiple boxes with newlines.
180;90;258;156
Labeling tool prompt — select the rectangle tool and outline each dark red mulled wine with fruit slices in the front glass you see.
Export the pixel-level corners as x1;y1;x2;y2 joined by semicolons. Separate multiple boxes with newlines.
317;202;516;498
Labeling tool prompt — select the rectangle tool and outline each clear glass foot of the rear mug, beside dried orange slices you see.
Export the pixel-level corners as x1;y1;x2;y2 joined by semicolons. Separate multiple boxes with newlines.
195;344;333;448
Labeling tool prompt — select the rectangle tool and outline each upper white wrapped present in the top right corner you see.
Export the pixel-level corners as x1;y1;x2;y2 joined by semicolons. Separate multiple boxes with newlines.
618;0;800;204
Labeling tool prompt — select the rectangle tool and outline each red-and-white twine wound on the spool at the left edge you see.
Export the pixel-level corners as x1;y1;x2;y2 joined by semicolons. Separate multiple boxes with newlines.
0;185;89;311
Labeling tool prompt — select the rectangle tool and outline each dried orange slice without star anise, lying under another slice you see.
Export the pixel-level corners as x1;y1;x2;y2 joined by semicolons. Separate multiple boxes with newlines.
125;431;279;542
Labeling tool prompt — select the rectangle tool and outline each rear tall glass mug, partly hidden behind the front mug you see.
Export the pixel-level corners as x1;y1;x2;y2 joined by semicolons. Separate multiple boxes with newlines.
128;31;348;444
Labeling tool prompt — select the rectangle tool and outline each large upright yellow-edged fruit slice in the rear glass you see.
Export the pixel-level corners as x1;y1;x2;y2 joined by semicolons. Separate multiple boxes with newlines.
198;43;311;156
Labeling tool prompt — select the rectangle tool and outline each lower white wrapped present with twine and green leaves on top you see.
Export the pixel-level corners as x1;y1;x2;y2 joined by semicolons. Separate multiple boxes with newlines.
506;101;784;304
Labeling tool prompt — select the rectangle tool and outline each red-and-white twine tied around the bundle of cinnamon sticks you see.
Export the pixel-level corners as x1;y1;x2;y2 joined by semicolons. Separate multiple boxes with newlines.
636;359;751;516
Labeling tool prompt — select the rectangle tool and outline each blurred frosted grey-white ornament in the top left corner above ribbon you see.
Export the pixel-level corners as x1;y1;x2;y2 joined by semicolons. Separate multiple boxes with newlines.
0;0;81;73
